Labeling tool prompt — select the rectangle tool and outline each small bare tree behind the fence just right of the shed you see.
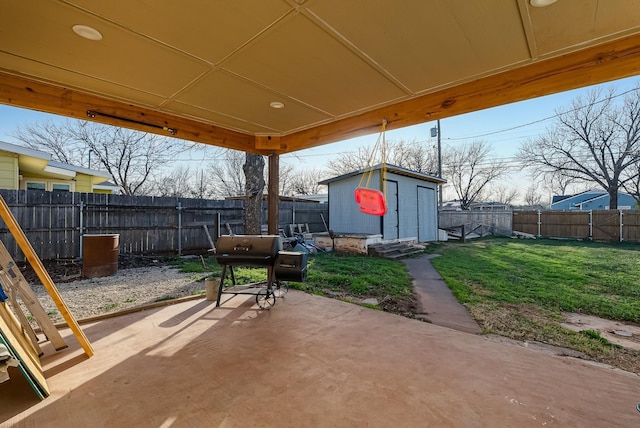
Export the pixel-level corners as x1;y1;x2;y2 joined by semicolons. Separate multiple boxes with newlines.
442;141;508;210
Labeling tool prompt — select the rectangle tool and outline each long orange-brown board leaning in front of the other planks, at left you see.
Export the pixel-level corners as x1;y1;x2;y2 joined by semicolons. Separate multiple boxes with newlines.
0;195;94;357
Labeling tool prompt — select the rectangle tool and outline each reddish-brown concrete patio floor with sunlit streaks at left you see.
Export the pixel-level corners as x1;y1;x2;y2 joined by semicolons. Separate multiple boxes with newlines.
0;291;640;427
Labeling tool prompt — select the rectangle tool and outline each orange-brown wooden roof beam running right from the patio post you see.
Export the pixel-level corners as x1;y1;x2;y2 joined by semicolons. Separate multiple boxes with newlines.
280;34;640;153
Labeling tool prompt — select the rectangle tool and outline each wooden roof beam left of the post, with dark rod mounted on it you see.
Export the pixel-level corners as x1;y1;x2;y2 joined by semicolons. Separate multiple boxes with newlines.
0;72;263;153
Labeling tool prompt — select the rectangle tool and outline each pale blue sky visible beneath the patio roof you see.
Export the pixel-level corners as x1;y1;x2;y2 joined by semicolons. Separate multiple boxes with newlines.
0;76;640;199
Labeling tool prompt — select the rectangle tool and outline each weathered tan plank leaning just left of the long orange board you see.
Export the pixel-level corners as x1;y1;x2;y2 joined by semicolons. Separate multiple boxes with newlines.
0;241;67;351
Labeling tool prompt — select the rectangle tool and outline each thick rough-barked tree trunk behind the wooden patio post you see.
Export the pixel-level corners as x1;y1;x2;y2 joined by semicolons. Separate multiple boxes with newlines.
242;153;265;235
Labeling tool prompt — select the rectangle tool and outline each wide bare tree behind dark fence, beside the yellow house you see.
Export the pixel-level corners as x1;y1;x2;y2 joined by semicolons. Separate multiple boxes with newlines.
13;120;188;195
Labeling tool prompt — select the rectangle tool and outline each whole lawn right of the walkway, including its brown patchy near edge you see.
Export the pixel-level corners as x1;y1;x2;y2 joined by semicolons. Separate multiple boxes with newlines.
428;238;640;374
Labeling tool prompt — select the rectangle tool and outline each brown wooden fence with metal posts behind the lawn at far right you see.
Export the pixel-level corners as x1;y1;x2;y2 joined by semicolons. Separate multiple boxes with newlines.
513;210;640;242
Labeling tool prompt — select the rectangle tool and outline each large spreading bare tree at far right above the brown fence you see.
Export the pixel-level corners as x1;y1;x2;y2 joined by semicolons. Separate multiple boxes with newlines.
518;87;640;209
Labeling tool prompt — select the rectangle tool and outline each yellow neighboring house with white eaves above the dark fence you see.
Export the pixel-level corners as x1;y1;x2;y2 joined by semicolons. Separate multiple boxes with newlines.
0;141;118;193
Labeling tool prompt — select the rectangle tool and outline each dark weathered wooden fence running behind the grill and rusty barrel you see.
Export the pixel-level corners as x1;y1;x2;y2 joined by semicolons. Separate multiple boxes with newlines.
0;189;328;261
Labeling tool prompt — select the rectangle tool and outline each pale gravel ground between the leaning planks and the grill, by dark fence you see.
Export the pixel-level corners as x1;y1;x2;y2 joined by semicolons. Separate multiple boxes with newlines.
32;265;205;322
